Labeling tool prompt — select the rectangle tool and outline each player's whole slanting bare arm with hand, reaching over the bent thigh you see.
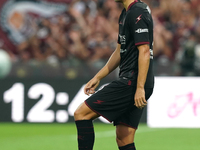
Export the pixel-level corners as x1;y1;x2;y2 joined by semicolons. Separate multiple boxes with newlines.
84;44;121;95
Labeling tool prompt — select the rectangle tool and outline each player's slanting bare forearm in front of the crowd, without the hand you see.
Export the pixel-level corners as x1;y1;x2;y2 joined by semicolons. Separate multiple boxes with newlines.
95;44;120;80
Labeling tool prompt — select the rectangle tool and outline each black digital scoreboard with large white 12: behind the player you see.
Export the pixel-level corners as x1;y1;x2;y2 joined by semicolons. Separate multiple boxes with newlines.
0;79;109;123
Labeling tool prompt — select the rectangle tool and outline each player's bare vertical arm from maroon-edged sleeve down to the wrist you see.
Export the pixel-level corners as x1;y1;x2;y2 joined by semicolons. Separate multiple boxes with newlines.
137;45;150;88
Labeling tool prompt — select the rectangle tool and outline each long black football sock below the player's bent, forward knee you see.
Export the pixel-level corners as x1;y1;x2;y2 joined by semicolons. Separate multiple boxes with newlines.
75;120;94;150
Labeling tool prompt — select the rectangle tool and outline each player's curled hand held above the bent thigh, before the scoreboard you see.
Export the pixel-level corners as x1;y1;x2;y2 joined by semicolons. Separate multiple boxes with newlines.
84;78;100;95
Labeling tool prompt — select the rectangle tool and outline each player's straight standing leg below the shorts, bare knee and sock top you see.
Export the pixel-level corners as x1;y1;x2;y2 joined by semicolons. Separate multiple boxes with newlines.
116;124;136;150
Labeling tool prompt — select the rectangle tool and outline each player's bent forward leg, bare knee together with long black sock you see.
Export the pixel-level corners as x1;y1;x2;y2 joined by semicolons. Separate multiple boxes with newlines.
74;103;99;150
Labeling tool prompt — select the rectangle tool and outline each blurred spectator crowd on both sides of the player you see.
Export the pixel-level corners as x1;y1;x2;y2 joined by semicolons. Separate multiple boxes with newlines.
3;0;200;76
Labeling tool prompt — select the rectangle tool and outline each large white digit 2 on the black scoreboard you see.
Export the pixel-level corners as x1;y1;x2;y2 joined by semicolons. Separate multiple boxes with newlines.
27;83;55;122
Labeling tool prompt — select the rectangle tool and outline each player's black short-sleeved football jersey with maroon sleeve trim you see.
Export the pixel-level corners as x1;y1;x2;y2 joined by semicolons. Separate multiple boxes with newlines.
118;0;154;88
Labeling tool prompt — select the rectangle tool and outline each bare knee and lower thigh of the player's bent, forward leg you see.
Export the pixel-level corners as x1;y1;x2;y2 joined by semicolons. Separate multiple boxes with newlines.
74;103;99;120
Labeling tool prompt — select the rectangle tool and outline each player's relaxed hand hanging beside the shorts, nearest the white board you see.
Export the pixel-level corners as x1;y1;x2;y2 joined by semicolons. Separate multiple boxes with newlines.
134;88;147;109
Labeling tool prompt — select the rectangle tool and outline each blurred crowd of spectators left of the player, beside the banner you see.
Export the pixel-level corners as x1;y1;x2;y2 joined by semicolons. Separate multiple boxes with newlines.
9;0;122;71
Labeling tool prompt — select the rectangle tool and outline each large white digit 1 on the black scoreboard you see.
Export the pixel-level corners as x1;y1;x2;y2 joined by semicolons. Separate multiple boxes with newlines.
3;83;24;122
